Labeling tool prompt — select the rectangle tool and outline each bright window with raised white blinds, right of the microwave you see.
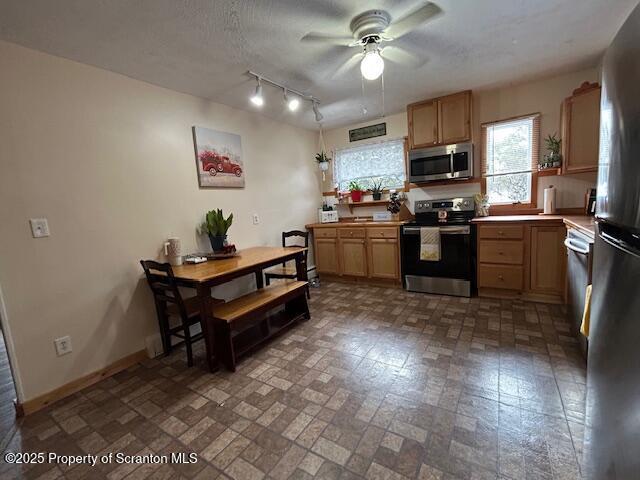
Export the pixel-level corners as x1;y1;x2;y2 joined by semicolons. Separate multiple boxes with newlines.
481;114;540;205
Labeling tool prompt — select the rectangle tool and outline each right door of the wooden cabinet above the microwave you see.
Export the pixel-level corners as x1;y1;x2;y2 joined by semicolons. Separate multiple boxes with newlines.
438;92;471;144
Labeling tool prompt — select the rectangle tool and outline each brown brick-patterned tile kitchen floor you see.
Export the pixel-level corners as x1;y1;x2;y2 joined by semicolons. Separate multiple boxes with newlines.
0;283;585;480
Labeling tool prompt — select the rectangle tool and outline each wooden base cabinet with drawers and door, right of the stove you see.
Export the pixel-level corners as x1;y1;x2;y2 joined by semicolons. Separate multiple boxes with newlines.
478;219;566;303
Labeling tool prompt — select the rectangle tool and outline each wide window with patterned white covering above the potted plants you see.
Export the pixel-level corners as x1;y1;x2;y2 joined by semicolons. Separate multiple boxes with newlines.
333;138;406;191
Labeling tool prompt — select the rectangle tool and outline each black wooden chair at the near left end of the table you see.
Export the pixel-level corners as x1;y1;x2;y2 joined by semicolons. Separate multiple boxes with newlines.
140;260;203;367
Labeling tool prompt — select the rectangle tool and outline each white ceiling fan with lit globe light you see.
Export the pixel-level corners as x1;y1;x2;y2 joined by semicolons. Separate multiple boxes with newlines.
300;2;442;80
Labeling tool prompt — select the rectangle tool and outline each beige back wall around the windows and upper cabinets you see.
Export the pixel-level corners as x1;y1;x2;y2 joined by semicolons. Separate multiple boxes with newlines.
323;68;600;216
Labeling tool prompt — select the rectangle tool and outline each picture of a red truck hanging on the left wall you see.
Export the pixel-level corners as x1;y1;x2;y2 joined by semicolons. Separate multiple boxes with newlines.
193;127;244;188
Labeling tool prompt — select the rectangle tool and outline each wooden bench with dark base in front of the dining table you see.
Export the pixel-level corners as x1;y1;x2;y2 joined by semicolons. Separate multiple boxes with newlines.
211;281;310;372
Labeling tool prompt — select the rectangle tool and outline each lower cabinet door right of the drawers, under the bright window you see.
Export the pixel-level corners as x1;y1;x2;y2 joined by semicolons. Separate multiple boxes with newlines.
529;226;566;296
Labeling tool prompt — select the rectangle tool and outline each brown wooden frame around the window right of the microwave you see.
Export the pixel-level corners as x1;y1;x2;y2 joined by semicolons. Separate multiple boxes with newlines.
480;112;541;213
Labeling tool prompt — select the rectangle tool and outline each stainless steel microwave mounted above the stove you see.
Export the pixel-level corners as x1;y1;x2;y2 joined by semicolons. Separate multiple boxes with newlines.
409;143;473;183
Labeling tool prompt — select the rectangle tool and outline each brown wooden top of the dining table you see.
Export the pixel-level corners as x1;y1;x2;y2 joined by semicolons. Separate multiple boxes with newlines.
173;247;307;282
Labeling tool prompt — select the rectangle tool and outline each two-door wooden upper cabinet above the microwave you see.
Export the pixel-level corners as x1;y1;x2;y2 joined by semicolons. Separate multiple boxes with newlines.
407;91;471;149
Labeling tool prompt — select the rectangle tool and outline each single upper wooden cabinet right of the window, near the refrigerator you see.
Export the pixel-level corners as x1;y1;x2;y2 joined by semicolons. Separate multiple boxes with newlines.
562;82;600;174
